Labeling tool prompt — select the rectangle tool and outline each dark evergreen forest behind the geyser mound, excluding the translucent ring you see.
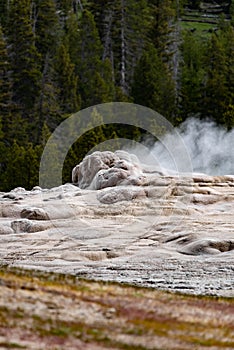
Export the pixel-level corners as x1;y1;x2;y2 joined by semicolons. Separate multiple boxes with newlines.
0;0;234;191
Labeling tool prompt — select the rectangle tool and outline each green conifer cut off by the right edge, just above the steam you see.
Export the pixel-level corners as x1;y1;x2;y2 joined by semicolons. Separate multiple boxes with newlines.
203;25;234;128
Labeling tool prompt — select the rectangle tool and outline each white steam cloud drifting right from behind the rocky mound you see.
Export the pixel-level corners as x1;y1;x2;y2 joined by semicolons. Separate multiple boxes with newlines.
123;118;234;175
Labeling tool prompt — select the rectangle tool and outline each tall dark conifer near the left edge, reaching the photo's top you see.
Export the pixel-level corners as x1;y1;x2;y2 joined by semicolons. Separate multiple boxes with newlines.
8;0;41;122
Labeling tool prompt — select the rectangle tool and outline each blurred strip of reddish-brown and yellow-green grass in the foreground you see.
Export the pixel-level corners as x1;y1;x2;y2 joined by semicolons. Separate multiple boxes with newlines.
0;267;234;350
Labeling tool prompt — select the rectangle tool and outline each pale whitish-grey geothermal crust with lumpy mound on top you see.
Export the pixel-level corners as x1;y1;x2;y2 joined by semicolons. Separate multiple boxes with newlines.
0;151;234;297
